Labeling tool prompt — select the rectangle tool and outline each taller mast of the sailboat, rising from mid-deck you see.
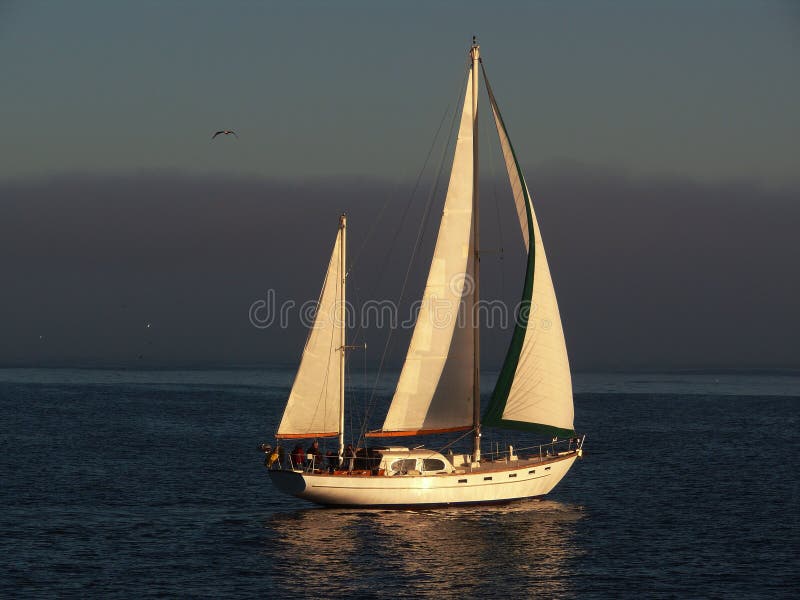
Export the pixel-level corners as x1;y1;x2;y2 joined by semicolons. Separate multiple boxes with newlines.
469;36;481;463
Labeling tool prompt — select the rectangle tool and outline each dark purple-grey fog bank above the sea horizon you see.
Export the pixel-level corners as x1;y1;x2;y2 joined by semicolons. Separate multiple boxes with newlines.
0;165;800;371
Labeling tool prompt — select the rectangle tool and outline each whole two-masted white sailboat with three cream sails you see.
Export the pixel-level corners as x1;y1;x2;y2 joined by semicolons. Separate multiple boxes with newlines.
265;38;585;507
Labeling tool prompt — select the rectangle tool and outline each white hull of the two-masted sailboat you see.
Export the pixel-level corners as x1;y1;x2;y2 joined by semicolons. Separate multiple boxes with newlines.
269;451;580;507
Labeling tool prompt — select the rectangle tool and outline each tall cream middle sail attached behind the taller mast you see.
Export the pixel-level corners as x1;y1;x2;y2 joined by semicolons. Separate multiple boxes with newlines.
369;73;474;436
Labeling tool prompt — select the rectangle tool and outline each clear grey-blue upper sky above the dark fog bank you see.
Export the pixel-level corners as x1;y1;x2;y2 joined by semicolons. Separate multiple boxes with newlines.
0;0;800;185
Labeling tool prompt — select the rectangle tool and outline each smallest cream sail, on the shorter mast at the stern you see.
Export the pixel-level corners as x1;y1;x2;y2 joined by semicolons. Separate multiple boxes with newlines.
276;224;345;438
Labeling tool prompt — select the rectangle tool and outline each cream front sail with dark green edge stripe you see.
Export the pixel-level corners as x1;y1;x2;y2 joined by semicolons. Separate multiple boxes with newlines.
483;71;574;435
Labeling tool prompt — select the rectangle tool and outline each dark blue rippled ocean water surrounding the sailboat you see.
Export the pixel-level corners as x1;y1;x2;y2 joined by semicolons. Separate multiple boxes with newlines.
0;369;800;598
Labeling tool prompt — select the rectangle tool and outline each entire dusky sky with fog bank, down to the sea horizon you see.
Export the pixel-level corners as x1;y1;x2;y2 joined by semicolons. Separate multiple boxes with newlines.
0;0;800;370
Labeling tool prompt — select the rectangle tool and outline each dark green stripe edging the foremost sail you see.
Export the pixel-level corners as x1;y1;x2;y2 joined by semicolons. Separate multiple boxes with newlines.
481;65;575;436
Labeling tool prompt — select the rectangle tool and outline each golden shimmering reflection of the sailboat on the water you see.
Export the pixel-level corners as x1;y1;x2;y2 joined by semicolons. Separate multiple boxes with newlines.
264;500;584;597
